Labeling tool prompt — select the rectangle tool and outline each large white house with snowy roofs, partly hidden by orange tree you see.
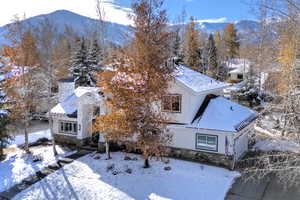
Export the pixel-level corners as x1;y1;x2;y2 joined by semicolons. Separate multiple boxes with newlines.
51;66;257;167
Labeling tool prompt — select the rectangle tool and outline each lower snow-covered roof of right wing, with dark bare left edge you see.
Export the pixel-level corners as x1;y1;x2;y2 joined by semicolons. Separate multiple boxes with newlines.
188;97;257;132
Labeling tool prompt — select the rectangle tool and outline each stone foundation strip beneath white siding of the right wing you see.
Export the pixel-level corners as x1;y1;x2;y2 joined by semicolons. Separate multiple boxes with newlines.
168;147;234;170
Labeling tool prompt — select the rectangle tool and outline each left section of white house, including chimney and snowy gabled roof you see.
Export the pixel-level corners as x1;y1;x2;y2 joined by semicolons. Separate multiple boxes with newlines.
49;78;105;146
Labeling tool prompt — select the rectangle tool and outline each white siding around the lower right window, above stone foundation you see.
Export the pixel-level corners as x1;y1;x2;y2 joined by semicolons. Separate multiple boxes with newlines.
169;126;234;155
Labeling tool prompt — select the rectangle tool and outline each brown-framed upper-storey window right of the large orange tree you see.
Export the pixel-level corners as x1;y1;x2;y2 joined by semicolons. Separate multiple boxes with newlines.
162;94;181;112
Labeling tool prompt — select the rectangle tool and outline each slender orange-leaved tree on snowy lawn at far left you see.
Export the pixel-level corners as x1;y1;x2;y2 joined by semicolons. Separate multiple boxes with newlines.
4;20;41;152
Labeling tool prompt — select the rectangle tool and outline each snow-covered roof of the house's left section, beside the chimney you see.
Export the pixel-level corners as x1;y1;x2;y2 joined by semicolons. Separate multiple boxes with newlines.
50;87;100;115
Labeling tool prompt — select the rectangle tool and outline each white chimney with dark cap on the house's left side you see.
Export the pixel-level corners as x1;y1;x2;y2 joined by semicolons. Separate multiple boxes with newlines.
58;77;75;102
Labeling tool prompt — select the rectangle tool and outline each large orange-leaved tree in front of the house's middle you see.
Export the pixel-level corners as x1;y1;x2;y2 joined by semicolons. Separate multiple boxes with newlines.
94;0;173;168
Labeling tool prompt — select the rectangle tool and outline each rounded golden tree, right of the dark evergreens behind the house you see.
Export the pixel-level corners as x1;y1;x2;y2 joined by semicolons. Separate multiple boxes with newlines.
223;24;240;59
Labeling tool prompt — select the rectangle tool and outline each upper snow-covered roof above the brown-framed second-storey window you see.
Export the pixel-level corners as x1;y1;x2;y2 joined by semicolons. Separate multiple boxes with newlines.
173;65;227;93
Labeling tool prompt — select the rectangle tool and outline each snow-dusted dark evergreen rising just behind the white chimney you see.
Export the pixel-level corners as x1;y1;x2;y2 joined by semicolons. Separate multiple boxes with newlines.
71;38;94;86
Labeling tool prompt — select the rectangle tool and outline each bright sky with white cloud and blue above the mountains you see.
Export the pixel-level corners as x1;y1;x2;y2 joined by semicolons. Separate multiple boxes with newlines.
0;0;254;26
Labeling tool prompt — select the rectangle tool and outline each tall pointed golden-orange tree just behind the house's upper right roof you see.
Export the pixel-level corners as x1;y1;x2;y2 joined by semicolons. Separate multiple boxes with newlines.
184;17;204;72
